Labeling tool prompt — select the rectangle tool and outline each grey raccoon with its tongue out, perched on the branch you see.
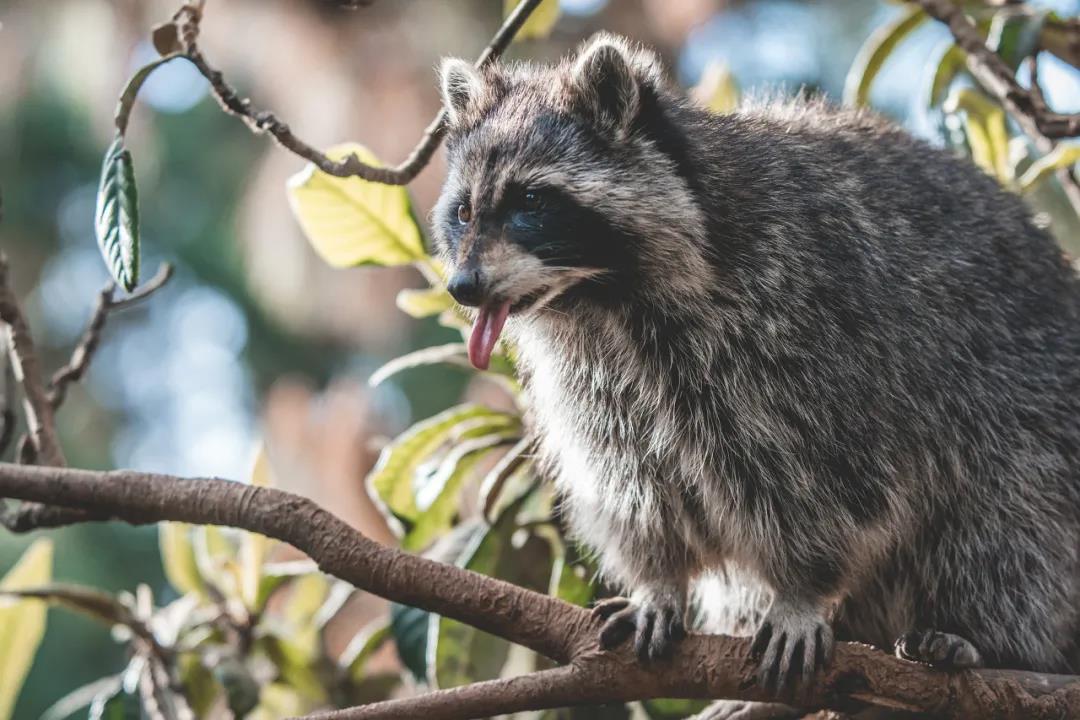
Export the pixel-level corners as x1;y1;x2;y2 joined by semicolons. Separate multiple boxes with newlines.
432;35;1080;690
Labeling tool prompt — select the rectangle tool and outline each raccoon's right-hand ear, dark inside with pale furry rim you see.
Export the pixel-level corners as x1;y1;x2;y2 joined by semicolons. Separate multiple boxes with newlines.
571;32;660;137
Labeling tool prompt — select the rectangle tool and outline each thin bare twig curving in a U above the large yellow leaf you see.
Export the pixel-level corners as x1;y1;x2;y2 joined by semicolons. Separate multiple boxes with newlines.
176;0;541;185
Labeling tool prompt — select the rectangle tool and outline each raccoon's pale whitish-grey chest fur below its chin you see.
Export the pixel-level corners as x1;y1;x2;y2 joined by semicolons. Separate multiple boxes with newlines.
518;321;723;562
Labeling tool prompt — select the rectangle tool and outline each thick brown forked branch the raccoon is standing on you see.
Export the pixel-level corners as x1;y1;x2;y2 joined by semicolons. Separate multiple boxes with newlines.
0;463;1080;720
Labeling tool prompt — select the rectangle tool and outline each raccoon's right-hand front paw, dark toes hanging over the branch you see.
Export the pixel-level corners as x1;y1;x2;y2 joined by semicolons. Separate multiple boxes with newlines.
751;600;833;694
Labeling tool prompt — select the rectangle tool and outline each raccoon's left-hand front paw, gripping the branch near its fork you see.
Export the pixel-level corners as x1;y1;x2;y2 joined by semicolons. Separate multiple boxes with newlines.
593;598;686;663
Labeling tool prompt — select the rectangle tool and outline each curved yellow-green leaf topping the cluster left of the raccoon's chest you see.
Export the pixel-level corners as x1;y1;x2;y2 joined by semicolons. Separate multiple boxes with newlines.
367;404;505;524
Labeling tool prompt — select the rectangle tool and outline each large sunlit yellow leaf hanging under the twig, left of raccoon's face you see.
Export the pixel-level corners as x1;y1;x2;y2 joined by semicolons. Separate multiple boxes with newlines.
287;144;426;268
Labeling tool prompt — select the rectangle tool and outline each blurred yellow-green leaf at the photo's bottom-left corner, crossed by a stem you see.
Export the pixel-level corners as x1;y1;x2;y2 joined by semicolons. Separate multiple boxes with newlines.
0;540;53;720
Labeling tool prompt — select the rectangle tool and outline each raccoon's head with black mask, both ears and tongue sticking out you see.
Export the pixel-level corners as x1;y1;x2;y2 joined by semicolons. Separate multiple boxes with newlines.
433;35;702;367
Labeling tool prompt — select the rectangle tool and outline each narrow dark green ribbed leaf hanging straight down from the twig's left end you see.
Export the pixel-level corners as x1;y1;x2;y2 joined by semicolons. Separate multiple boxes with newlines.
94;135;139;293
